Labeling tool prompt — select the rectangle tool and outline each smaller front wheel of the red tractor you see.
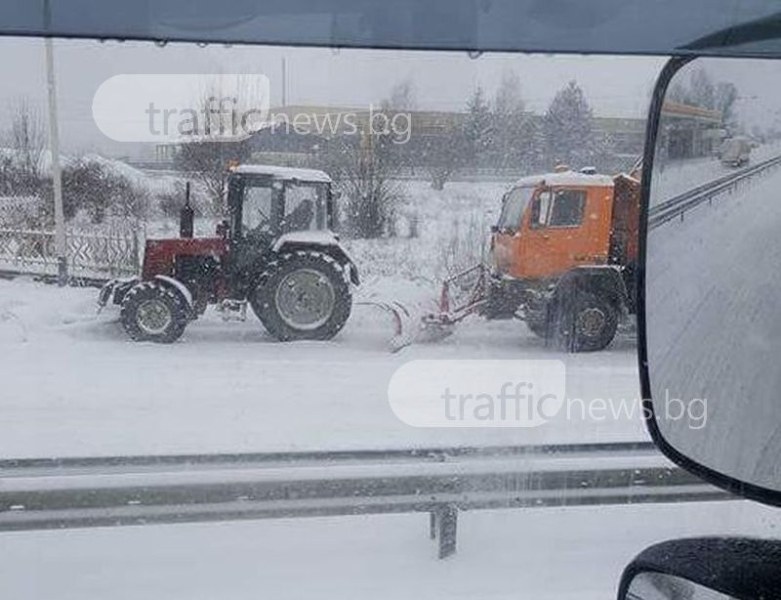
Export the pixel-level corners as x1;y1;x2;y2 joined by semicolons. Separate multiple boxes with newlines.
120;281;188;344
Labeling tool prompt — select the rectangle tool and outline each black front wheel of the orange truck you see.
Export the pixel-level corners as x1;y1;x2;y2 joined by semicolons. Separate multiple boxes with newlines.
556;292;618;352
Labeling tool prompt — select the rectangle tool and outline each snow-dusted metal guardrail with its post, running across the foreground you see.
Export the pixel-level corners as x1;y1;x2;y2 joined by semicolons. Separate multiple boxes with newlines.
0;443;732;558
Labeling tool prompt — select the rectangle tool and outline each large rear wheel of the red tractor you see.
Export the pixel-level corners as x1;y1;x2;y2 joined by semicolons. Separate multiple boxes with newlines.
250;251;352;341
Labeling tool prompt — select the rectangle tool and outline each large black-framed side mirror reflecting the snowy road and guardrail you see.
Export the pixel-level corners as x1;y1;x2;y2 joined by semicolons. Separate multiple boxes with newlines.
638;58;781;504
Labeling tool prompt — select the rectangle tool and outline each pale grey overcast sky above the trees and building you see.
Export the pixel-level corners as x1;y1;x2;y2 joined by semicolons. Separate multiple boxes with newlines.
0;38;781;155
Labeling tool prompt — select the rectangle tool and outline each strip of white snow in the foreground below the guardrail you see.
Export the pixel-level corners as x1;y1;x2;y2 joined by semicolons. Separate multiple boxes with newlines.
0;501;781;600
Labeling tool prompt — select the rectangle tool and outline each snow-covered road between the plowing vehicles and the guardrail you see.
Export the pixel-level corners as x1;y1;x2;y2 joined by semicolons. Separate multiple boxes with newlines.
0;280;646;457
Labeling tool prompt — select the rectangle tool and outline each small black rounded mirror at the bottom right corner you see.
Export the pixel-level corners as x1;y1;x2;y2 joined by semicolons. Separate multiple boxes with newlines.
618;538;781;600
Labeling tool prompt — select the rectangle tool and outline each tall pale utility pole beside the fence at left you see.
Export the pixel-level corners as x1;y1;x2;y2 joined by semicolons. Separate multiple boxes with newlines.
43;0;68;286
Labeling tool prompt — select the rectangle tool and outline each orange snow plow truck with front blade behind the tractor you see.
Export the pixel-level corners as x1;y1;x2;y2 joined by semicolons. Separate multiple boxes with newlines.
424;168;640;352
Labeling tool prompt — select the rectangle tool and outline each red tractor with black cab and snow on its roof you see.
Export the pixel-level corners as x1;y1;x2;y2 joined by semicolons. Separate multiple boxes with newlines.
98;165;359;343
